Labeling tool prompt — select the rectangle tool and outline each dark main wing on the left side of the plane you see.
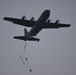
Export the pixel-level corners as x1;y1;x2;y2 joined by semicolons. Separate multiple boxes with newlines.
4;17;36;27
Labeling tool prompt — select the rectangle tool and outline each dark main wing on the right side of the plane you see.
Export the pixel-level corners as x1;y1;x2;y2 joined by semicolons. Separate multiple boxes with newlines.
43;23;71;29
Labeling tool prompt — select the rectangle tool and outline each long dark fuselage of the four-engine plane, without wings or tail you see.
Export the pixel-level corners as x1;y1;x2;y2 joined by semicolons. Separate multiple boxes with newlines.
28;10;50;36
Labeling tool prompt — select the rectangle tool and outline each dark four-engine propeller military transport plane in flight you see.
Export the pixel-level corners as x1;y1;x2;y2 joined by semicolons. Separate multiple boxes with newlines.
4;10;70;41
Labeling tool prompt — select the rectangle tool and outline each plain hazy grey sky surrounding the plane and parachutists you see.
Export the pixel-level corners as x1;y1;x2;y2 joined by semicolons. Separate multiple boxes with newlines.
0;0;76;75
